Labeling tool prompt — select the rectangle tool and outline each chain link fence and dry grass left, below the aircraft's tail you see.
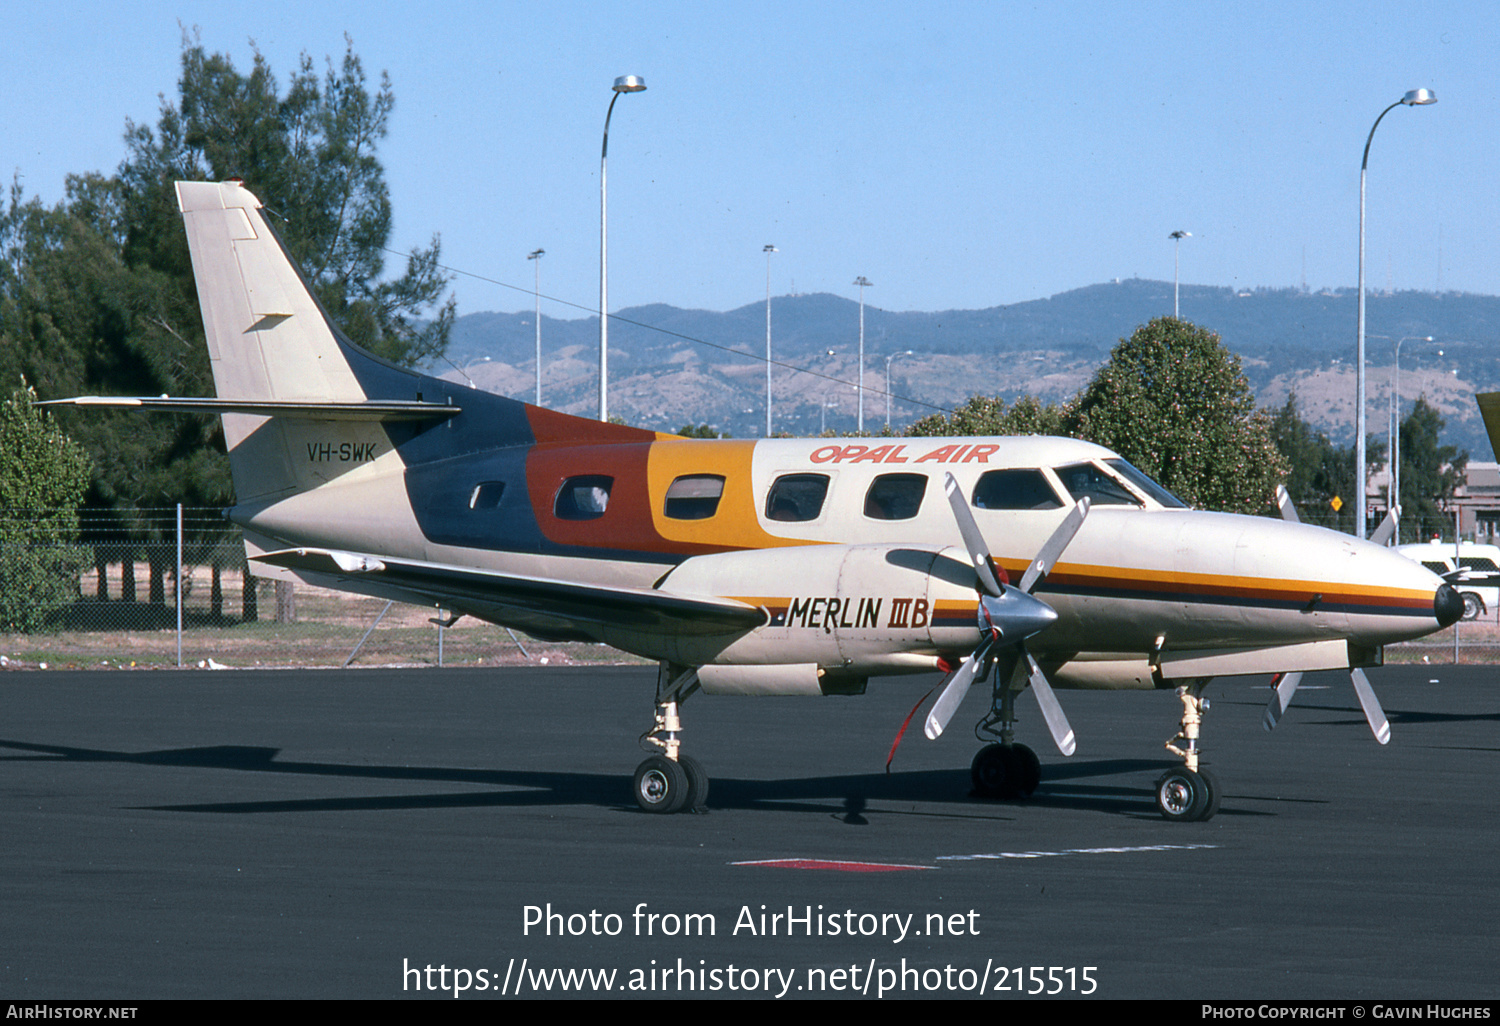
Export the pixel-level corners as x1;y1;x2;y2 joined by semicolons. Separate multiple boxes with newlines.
0;507;639;669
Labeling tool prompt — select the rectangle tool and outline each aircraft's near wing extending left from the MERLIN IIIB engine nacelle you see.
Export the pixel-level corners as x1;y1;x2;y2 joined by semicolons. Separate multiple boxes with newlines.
251;549;768;641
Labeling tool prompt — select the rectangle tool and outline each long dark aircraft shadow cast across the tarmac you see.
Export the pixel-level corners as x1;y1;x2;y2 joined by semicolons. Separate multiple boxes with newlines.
0;740;1269;825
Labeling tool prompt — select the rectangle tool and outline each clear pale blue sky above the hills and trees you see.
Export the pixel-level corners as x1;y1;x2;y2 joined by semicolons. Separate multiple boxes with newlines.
0;0;1500;317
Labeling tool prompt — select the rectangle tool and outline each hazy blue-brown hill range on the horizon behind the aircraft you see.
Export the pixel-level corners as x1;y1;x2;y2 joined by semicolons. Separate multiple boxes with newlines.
435;279;1500;459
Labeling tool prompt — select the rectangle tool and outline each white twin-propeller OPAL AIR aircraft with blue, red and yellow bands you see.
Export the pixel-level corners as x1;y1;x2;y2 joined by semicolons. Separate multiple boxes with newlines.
49;182;1463;821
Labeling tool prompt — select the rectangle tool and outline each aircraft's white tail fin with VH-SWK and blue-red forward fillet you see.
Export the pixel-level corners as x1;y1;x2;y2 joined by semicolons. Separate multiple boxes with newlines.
174;182;654;507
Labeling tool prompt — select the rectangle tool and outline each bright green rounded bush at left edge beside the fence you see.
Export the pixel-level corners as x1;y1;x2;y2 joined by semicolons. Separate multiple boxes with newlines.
0;389;89;632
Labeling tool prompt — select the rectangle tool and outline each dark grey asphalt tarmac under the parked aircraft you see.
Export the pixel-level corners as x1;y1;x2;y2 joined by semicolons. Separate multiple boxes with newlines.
0;666;1500;1002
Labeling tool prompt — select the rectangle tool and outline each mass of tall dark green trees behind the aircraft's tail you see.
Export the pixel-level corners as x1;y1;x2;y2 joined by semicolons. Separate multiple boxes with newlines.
0;39;455;507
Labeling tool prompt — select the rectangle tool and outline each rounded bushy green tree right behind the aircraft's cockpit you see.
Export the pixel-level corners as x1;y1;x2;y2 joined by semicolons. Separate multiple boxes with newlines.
1065;317;1287;513
